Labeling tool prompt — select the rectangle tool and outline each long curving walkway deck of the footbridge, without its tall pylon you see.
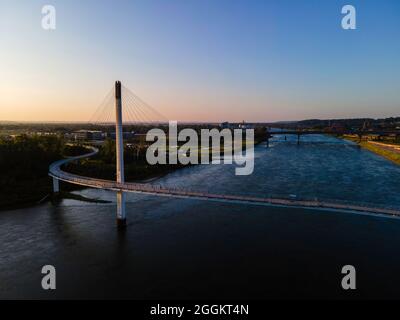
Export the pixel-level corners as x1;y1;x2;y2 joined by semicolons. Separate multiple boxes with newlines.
49;147;400;217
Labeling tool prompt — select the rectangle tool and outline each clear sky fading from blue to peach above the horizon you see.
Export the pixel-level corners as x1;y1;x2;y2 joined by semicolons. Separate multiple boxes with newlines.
0;0;400;121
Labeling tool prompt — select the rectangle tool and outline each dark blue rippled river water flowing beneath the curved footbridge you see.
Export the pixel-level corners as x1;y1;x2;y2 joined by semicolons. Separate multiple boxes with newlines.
0;136;400;299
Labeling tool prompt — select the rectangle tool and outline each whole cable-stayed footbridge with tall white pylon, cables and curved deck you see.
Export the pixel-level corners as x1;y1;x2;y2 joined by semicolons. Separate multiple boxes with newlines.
49;81;400;227
